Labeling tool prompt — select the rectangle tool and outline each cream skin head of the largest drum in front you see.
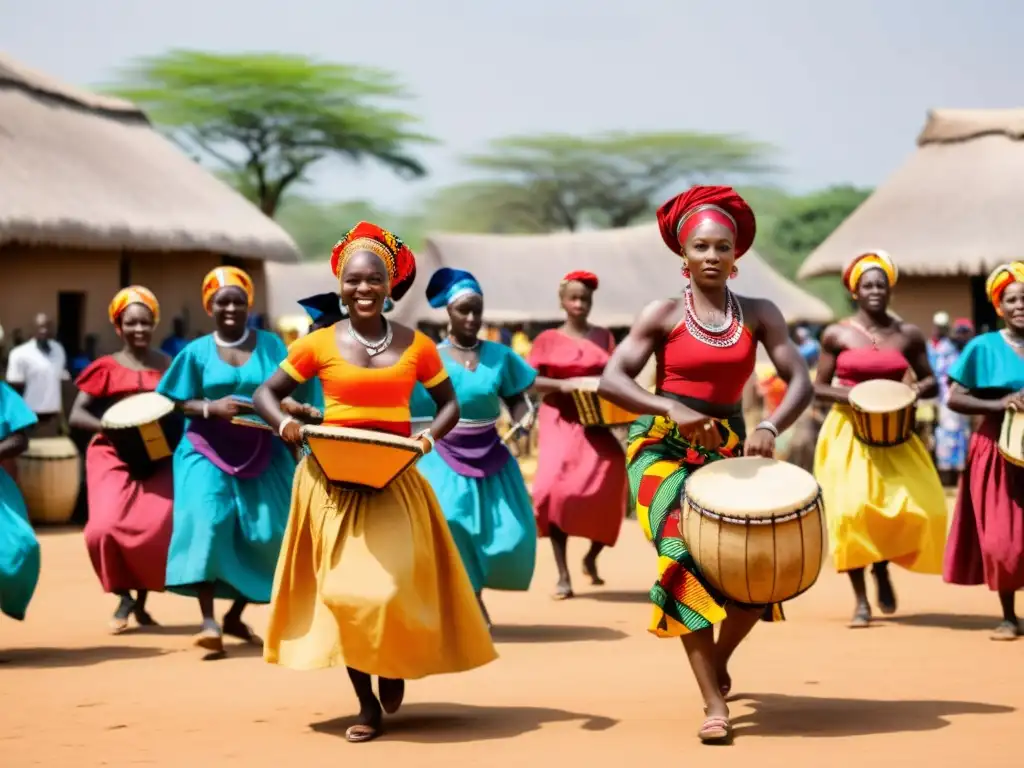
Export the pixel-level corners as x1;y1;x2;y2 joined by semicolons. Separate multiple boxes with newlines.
683;456;820;519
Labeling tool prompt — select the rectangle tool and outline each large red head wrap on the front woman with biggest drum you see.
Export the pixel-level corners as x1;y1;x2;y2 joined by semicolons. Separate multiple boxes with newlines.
657;185;758;258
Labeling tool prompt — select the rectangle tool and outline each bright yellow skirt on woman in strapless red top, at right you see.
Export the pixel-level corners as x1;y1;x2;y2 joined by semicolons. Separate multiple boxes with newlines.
814;406;947;573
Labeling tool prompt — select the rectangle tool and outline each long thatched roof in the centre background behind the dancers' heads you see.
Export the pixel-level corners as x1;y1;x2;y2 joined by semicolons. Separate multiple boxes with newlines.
267;224;833;327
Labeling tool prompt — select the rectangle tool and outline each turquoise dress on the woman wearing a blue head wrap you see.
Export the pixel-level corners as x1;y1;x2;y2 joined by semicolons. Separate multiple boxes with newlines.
411;341;537;592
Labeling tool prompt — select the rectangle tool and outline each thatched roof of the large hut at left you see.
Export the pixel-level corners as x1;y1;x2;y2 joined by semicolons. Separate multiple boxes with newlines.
0;54;299;261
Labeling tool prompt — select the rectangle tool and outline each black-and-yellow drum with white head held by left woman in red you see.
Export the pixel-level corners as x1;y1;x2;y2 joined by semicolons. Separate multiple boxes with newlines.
100;392;184;477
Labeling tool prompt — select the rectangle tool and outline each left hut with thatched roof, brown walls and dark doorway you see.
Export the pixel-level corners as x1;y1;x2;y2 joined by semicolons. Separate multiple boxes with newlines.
0;55;299;354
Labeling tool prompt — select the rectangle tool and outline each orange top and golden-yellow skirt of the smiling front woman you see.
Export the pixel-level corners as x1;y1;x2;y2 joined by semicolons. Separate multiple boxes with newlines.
263;328;498;680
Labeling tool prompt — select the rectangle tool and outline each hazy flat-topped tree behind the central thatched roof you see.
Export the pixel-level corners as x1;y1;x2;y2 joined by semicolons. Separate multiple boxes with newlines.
434;133;771;231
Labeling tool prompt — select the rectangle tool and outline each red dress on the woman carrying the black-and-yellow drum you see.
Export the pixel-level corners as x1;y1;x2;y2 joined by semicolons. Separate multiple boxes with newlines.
75;355;174;592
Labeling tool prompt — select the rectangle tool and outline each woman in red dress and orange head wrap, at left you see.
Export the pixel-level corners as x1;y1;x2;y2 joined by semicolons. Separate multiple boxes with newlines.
69;286;174;634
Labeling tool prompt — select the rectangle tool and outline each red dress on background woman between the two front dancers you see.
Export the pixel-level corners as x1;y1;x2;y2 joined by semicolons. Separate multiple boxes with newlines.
529;329;627;547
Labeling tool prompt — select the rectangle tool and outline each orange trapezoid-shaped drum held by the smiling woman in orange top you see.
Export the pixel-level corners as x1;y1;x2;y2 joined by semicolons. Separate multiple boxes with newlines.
302;425;423;490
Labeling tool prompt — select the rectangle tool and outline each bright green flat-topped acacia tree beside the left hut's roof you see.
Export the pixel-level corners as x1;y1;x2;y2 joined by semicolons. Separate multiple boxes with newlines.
111;50;432;216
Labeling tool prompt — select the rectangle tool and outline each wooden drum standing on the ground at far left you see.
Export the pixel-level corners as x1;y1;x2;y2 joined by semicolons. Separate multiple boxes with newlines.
17;437;82;524
